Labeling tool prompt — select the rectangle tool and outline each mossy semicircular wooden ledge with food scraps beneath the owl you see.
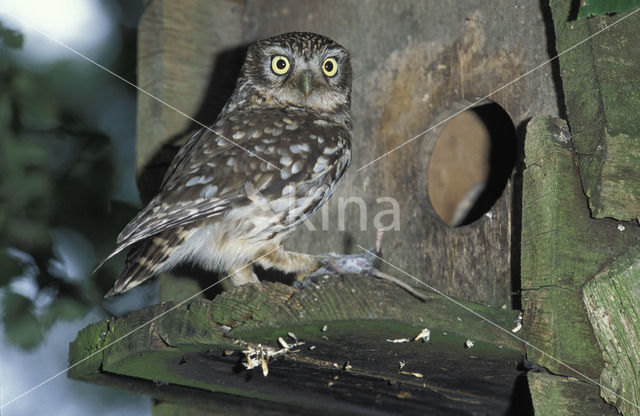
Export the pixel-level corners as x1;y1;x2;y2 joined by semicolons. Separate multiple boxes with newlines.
69;275;523;414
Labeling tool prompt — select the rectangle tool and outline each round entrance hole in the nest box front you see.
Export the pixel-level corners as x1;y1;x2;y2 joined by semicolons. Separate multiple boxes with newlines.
427;103;517;227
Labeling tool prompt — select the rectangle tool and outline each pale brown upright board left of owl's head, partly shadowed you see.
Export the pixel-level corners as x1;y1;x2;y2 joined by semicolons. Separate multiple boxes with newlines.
136;0;243;201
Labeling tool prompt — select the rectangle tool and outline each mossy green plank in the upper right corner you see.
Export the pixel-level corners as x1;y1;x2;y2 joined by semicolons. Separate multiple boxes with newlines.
550;0;640;221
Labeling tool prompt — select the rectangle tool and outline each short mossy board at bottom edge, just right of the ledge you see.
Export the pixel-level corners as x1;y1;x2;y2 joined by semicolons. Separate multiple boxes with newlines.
527;372;618;416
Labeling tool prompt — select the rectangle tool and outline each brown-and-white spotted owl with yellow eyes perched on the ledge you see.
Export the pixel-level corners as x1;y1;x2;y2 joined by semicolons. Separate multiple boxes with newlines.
105;32;351;297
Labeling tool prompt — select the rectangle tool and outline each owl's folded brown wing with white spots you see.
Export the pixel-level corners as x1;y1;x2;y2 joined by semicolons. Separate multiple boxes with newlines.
98;110;350;261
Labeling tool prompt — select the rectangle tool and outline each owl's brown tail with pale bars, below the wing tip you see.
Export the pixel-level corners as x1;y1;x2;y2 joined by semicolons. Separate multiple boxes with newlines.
104;227;190;298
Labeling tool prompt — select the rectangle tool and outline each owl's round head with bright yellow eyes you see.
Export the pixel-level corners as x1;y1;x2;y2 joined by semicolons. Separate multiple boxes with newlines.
237;32;351;113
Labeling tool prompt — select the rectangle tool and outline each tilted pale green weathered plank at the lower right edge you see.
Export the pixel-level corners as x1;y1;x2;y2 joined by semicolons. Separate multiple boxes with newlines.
582;246;640;416
